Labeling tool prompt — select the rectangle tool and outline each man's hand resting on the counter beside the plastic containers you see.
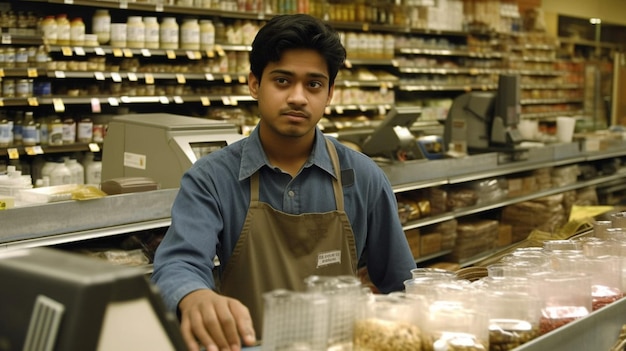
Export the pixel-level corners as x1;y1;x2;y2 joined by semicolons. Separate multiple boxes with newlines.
178;289;256;351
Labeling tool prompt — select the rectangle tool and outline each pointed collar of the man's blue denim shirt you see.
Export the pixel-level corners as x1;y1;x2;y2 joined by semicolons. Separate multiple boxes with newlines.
239;126;336;180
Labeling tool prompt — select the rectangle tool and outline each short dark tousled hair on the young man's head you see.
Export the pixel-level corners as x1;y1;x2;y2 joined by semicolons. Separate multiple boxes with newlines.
250;14;346;86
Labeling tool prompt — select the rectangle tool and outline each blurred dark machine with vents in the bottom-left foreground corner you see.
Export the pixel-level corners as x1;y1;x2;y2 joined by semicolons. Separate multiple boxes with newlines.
0;248;186;351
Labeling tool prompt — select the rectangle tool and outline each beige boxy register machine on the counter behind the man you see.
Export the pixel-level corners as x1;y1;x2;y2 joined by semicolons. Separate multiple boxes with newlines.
102;113;243;189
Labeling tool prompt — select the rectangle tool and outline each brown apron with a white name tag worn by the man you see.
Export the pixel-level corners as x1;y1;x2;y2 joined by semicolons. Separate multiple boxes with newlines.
221;139;357;338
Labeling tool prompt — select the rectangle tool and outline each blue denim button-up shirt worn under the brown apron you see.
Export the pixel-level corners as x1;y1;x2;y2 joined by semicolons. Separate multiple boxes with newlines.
152;129;416;311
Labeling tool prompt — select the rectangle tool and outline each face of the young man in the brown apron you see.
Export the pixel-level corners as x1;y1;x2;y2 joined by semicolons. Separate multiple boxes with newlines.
248;49;333;142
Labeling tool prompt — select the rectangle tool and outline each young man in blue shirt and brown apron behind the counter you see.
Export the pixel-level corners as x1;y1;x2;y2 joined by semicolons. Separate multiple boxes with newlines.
153;14;416;350
